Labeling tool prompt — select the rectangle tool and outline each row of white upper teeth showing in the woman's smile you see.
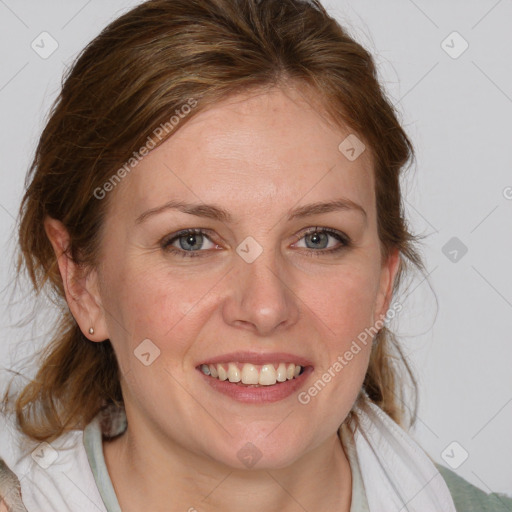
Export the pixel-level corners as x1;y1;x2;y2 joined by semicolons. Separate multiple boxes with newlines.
198;362;306;387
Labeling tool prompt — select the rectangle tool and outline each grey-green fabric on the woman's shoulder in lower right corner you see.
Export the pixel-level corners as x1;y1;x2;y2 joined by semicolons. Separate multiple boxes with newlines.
435;464;512;512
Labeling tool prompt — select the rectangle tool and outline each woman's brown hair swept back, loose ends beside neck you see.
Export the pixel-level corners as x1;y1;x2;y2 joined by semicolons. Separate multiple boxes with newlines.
6;0;424;441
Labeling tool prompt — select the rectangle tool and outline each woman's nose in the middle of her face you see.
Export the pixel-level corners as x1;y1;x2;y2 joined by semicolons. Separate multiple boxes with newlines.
223;244;299;336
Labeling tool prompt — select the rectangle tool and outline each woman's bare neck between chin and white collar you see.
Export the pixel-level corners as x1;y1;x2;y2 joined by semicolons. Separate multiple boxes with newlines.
104;420;352;512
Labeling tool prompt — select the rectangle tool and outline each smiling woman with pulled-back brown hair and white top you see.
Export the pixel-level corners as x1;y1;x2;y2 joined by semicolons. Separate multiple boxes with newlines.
0;0;505;512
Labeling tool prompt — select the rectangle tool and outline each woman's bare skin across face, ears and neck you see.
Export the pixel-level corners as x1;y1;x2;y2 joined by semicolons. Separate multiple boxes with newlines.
45;89;398;512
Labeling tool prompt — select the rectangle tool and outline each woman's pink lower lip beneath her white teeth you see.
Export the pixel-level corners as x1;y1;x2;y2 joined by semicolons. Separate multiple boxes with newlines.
198;366;313;404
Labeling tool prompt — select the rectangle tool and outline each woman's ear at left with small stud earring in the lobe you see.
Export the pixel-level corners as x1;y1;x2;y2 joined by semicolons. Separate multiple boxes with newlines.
44;216;109;342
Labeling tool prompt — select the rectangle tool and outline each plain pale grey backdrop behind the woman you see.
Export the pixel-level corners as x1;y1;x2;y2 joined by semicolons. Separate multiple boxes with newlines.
0;0;512;494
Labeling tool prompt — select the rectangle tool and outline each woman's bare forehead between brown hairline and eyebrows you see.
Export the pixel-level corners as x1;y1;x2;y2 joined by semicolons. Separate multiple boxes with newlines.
114;89;374;222
